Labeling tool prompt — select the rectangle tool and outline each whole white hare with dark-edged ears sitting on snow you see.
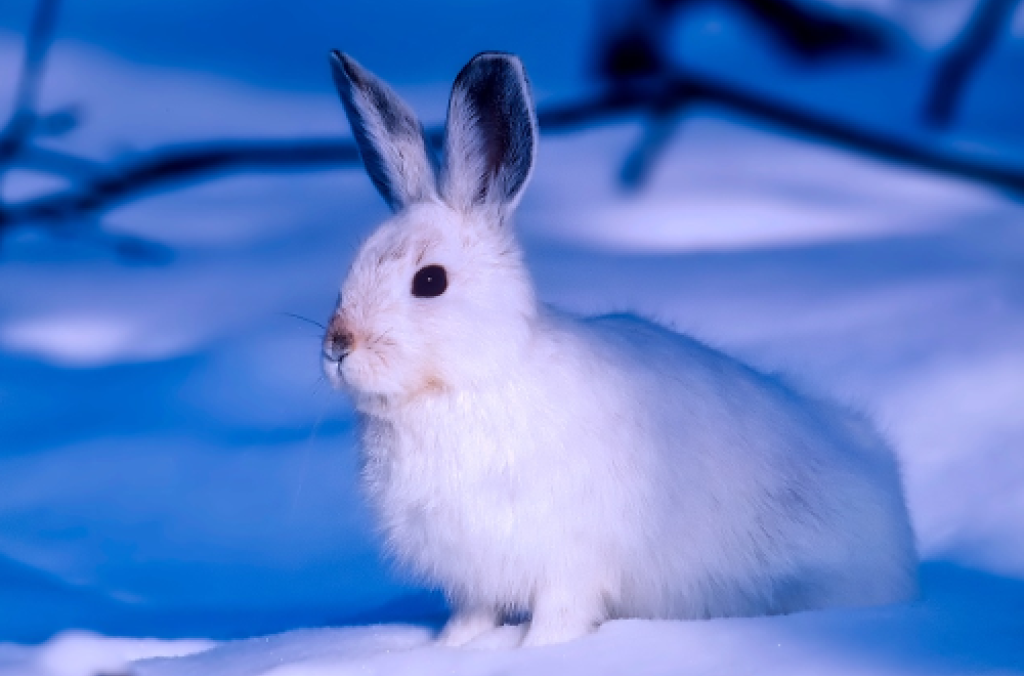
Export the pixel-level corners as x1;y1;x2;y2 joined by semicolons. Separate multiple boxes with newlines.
324;52;916;645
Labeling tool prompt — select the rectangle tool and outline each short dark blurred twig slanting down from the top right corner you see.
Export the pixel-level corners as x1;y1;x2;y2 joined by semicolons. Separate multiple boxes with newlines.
924;0;1017;129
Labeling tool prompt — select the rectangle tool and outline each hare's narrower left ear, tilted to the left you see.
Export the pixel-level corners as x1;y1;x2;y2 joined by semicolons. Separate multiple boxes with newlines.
331;50;437;211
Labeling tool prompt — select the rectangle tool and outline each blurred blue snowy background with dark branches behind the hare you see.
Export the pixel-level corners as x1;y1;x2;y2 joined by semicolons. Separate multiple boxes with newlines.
0;0;1024;655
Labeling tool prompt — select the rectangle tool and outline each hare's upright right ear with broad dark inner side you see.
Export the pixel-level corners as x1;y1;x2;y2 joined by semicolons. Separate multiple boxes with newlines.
440;52;537;210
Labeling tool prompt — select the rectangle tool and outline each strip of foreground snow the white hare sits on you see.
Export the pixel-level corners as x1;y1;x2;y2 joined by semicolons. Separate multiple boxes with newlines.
14;564;1024;676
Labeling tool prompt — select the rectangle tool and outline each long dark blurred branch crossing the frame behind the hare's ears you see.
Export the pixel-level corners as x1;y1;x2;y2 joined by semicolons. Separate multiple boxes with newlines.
0;75;1024;234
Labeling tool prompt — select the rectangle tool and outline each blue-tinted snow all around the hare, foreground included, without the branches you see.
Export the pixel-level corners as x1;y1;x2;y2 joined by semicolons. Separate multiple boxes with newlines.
0;0;1024;676
